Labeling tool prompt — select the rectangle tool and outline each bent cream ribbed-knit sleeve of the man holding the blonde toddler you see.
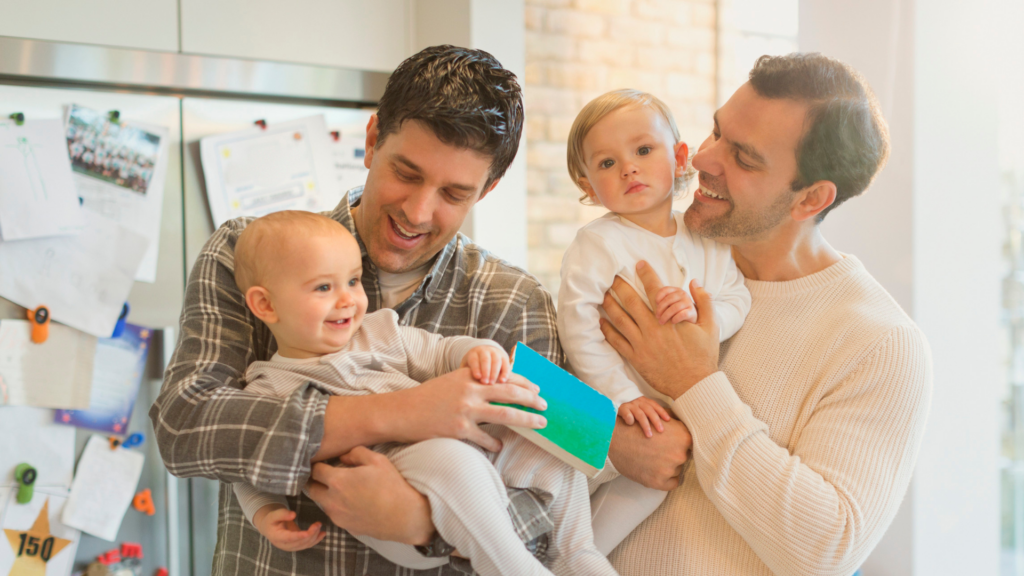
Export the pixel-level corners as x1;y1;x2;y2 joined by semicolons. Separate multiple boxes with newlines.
673;326;932;576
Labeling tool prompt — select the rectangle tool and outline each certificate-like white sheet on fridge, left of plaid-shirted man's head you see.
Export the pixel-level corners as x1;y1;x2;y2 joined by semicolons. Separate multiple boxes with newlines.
200;115;339;227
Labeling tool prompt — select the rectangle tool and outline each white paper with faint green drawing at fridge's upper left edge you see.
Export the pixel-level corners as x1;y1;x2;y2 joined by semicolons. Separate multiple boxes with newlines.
0;120;82;241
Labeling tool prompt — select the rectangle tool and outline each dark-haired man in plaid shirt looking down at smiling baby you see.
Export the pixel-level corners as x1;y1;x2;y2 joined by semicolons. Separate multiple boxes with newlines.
150;46;564;575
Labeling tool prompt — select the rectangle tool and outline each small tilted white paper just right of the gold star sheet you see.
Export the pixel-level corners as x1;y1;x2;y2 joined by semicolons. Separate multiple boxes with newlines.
60;435;145;541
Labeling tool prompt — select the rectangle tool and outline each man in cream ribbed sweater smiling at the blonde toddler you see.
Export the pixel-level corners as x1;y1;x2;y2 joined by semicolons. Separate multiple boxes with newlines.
602;54;932;576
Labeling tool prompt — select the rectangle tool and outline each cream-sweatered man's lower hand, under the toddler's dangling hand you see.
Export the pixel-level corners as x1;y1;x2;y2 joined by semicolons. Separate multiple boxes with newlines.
608;412;693;491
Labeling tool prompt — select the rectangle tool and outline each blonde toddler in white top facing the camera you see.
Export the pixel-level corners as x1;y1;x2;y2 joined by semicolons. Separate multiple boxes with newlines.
558;90;751;554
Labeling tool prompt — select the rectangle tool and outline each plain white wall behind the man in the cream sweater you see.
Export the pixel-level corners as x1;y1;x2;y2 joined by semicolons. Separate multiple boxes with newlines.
800;0;1002;576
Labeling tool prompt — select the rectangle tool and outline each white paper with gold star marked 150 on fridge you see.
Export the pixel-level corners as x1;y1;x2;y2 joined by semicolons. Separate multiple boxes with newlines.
0;481;82;576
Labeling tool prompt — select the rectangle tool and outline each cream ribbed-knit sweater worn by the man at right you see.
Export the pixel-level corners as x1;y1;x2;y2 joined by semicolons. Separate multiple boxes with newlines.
609;256;932;576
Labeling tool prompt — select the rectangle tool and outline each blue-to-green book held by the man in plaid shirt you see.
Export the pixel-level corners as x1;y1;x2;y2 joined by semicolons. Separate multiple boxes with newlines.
497;342;615;478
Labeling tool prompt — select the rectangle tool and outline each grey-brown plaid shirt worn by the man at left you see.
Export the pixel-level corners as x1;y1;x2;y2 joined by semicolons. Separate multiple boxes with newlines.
150;188;565;576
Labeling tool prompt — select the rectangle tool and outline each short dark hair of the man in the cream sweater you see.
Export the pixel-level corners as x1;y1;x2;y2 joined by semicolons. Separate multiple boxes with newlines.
751;53;889;222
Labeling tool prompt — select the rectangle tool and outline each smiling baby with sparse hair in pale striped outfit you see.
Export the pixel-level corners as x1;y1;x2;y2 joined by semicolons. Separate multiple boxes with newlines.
234;211;616;576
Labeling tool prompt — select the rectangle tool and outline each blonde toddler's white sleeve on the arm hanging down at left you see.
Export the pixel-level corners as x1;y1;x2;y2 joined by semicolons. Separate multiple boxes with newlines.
558;230;643;406
